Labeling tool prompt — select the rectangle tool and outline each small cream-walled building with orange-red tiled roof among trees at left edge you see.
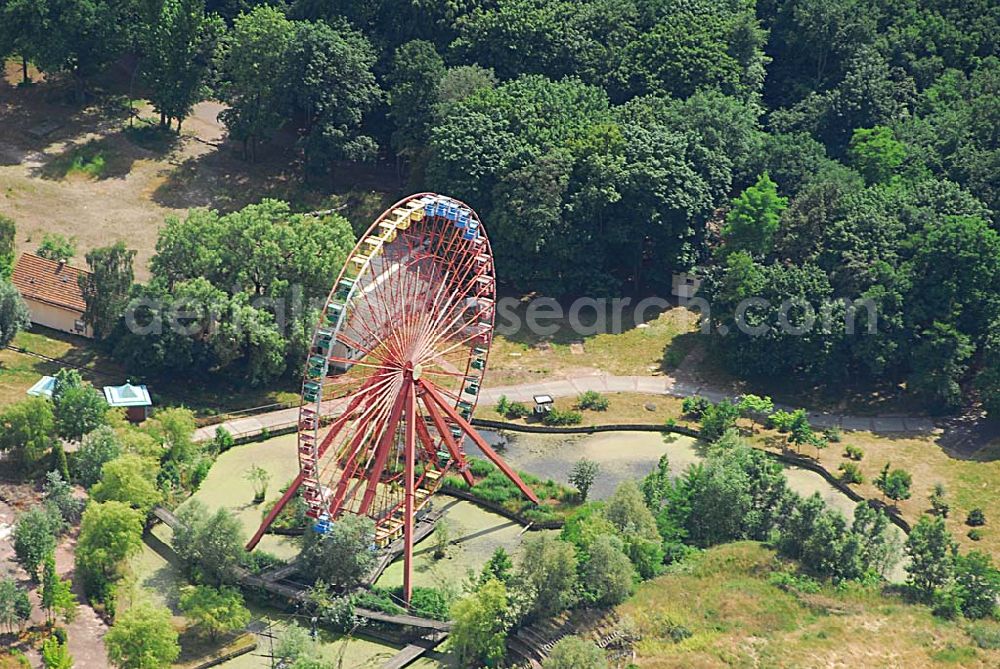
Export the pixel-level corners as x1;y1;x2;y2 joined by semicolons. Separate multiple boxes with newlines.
11;253;94;337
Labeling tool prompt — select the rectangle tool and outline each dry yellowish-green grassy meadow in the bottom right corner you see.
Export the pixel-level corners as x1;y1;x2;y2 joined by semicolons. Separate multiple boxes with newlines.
618;542;1000;669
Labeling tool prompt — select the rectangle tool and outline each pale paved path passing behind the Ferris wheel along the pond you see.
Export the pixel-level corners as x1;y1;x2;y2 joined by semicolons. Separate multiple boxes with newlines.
195;375;935;441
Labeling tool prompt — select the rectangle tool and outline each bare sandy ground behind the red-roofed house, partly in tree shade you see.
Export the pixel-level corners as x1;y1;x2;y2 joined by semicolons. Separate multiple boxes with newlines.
0;62;302;280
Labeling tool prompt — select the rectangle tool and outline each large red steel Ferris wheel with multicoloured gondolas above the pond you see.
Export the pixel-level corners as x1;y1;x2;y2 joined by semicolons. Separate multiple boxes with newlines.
247;193;538;602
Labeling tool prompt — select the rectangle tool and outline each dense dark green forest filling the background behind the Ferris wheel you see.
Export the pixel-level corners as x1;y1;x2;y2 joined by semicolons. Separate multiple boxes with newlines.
0;0;1000;411
